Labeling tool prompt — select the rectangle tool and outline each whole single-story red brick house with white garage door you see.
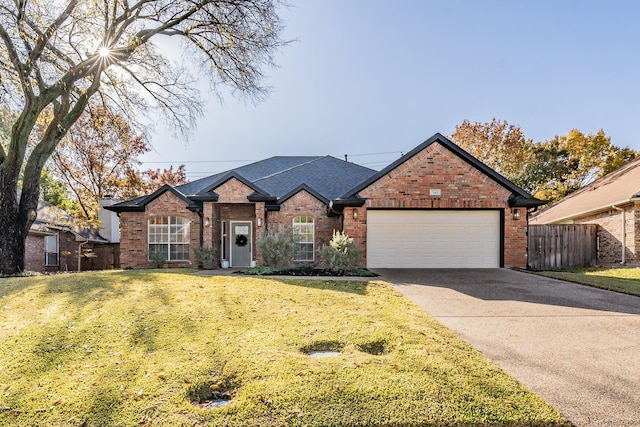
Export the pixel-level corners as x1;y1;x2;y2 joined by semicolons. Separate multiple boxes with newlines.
107;134;543;268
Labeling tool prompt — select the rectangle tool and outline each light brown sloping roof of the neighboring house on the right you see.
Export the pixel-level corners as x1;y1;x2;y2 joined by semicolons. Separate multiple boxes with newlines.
531;158;640;224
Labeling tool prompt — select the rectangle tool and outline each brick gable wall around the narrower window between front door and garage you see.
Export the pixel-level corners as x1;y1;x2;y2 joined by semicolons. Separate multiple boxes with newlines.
267;190;340;262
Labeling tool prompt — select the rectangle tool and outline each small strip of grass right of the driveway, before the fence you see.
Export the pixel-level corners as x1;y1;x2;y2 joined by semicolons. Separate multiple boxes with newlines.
535;268;640;296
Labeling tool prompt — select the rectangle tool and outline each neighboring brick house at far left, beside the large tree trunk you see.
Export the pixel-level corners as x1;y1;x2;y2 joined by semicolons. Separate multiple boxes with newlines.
25;196;119;273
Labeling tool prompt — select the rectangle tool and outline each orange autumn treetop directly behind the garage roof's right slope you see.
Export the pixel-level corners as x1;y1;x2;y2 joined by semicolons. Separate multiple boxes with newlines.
451;118;533;184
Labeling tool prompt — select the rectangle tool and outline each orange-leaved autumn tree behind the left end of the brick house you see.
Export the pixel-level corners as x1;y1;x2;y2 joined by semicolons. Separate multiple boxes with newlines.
49;107;149;225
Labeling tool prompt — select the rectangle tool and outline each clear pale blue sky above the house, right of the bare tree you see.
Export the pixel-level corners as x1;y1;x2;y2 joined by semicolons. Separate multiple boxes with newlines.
141;0;640;180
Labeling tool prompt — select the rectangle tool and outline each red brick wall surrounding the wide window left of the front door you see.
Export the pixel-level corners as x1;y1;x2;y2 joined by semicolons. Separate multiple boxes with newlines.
120;191;200;268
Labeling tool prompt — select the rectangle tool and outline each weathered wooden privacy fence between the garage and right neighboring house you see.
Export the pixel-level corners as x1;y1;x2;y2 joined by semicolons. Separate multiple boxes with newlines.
528;224;598;270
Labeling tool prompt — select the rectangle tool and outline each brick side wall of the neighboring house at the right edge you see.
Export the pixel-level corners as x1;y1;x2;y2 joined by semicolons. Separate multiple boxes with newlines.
573;203;640;264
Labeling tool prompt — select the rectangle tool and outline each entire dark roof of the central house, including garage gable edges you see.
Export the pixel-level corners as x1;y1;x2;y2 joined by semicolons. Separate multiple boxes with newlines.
107;133;544;212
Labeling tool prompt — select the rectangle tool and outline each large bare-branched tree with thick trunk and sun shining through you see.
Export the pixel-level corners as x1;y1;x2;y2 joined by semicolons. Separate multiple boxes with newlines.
0;0;283;274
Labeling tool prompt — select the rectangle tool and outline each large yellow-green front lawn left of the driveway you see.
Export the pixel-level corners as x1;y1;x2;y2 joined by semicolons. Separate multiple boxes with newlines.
0;270;566;427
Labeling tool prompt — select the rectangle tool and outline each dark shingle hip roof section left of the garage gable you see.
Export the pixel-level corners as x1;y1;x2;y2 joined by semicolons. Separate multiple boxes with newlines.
108;156;376;211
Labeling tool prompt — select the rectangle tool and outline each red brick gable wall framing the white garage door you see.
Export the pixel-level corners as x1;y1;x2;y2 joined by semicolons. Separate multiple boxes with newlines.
344;142;527;267
